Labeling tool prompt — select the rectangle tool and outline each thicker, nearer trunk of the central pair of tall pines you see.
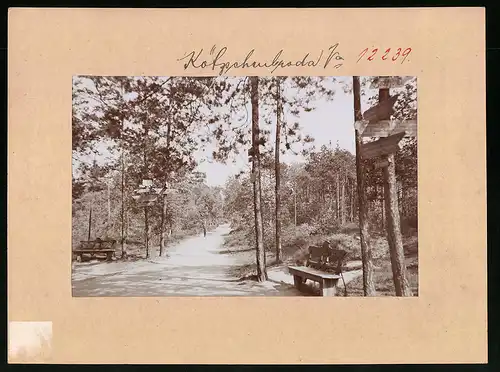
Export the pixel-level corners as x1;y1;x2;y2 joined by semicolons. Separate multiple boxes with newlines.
250;76;267;281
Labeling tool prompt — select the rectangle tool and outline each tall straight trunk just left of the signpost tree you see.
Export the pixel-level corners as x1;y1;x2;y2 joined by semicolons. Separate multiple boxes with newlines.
353;76;376;296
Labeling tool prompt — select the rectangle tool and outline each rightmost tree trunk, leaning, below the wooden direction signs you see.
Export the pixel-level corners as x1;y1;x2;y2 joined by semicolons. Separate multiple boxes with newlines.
384;154;412;297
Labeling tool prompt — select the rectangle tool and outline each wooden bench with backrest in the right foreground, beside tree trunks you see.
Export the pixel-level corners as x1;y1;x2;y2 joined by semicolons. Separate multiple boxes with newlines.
288;242;347;296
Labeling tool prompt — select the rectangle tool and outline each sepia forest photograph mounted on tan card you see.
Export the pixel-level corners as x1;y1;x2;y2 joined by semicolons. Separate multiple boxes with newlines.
72;76;419;297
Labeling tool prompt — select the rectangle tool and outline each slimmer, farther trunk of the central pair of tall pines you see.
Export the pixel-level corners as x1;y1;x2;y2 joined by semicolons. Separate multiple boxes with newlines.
274;77;281;263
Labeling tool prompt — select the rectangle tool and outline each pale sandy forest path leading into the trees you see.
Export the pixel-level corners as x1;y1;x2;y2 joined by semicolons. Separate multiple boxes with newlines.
72;225;301;297
